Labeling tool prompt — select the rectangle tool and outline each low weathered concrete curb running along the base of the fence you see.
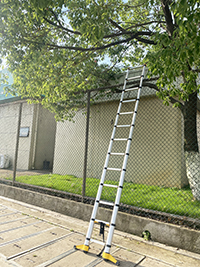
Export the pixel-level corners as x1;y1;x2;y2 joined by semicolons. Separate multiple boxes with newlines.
0;184;200;253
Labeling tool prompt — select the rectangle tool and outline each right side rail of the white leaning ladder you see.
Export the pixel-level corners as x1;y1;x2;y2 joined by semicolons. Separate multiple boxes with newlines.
104;65;145;254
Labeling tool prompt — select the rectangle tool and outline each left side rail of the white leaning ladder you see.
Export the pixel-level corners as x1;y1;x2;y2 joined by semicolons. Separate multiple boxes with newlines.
84;69;129;246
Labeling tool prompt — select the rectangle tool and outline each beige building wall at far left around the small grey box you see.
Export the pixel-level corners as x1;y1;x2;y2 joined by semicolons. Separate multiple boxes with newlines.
0;101;56;170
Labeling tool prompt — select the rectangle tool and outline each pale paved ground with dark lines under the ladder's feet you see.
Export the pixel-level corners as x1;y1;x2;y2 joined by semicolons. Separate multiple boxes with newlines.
0;197;200;267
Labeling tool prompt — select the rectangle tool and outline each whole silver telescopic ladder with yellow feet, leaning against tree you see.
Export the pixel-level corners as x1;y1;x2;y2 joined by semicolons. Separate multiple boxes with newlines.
74;64;146;266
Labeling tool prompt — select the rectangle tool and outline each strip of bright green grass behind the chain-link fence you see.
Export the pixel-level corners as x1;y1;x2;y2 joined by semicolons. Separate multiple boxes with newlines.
6;174;200;218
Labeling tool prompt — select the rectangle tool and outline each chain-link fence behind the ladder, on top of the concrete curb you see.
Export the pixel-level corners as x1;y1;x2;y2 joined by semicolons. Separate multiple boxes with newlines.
0;68;200;228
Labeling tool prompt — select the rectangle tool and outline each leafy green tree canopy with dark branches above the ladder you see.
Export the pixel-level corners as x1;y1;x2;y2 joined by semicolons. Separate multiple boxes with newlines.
0;0;200;119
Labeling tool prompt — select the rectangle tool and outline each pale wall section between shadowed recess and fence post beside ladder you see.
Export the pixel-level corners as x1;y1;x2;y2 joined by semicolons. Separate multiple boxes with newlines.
53;111;86;177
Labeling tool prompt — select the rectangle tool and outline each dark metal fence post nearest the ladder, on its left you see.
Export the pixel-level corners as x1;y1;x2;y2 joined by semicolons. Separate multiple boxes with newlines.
82;91;90;201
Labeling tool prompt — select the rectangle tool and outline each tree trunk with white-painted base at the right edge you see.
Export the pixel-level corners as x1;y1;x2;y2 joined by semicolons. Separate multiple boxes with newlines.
183;92;200;200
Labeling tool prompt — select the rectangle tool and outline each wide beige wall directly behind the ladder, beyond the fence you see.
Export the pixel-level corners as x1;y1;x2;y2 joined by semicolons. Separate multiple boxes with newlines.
53;97;187;187
